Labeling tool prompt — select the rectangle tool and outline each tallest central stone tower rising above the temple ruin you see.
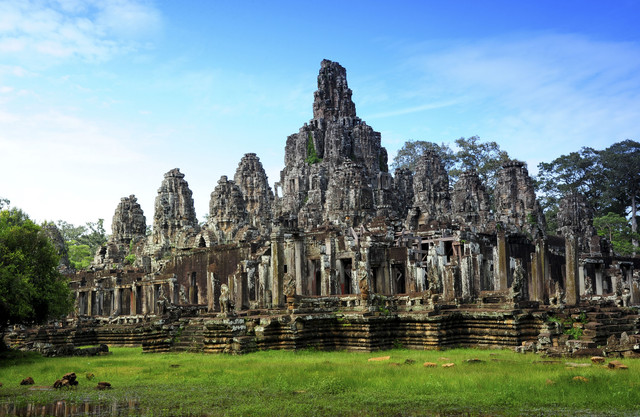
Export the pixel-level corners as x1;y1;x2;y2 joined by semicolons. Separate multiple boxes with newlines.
277;60;393;229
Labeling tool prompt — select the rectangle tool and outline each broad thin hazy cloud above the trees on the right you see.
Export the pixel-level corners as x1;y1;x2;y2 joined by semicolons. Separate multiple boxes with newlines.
398;33;640;166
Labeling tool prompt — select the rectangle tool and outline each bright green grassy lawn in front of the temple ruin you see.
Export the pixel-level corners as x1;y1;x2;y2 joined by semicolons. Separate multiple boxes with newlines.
0;348;640;416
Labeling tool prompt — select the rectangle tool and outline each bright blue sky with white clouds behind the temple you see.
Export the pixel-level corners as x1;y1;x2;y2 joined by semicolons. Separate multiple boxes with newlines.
0;0;640;229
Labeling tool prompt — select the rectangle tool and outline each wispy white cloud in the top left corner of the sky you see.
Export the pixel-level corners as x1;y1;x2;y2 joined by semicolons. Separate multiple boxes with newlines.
0;0;162;64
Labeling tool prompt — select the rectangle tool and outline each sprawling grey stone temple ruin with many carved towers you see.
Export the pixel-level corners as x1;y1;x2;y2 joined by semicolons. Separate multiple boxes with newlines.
7;60;640;353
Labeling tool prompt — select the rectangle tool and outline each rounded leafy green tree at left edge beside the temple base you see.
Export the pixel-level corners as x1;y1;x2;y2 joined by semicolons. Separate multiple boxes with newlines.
0;208;72;331
